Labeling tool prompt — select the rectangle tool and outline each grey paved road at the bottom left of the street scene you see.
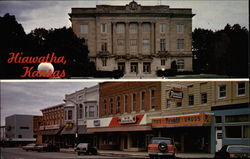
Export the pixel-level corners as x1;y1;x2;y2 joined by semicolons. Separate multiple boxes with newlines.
1;148;129;159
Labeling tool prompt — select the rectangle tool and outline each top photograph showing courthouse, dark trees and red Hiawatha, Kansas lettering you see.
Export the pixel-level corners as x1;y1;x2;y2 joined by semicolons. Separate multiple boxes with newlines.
0;0;249;80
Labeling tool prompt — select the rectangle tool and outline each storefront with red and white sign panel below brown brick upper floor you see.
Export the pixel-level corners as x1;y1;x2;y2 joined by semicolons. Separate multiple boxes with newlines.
87;114;153;151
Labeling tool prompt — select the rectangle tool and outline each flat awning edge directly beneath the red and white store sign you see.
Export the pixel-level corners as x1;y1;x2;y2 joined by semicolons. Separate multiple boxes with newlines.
87;125;152;133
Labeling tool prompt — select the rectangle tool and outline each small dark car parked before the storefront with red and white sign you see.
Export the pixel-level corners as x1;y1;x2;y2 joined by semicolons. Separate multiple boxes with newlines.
75;143;97;155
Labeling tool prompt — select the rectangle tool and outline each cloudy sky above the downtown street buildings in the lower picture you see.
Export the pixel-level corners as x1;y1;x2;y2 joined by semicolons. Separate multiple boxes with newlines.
1;81;97;125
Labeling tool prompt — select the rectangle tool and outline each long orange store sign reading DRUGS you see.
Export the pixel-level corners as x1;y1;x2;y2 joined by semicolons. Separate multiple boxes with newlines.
152;113;211;127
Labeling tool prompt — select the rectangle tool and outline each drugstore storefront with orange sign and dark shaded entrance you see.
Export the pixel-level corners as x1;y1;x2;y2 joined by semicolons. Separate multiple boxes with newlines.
151;113;211;152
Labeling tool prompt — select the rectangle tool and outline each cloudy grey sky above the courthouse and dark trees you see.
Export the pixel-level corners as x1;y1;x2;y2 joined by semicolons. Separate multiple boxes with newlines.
0;0;249;33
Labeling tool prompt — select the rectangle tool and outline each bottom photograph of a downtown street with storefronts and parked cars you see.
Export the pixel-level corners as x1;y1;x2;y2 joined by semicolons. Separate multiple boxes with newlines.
0;80;250;159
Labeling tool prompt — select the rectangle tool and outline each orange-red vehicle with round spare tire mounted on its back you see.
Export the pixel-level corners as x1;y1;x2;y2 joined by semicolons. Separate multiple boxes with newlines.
148;137;176;159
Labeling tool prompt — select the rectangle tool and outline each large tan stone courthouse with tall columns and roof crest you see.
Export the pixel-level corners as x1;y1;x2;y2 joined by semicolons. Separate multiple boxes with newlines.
69;1;194;77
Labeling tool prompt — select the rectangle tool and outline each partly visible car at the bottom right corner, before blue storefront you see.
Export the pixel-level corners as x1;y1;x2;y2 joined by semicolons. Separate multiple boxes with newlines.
214;145;250;158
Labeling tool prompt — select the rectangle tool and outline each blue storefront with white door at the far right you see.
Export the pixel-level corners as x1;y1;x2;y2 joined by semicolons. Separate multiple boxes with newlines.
211;103;250;153
